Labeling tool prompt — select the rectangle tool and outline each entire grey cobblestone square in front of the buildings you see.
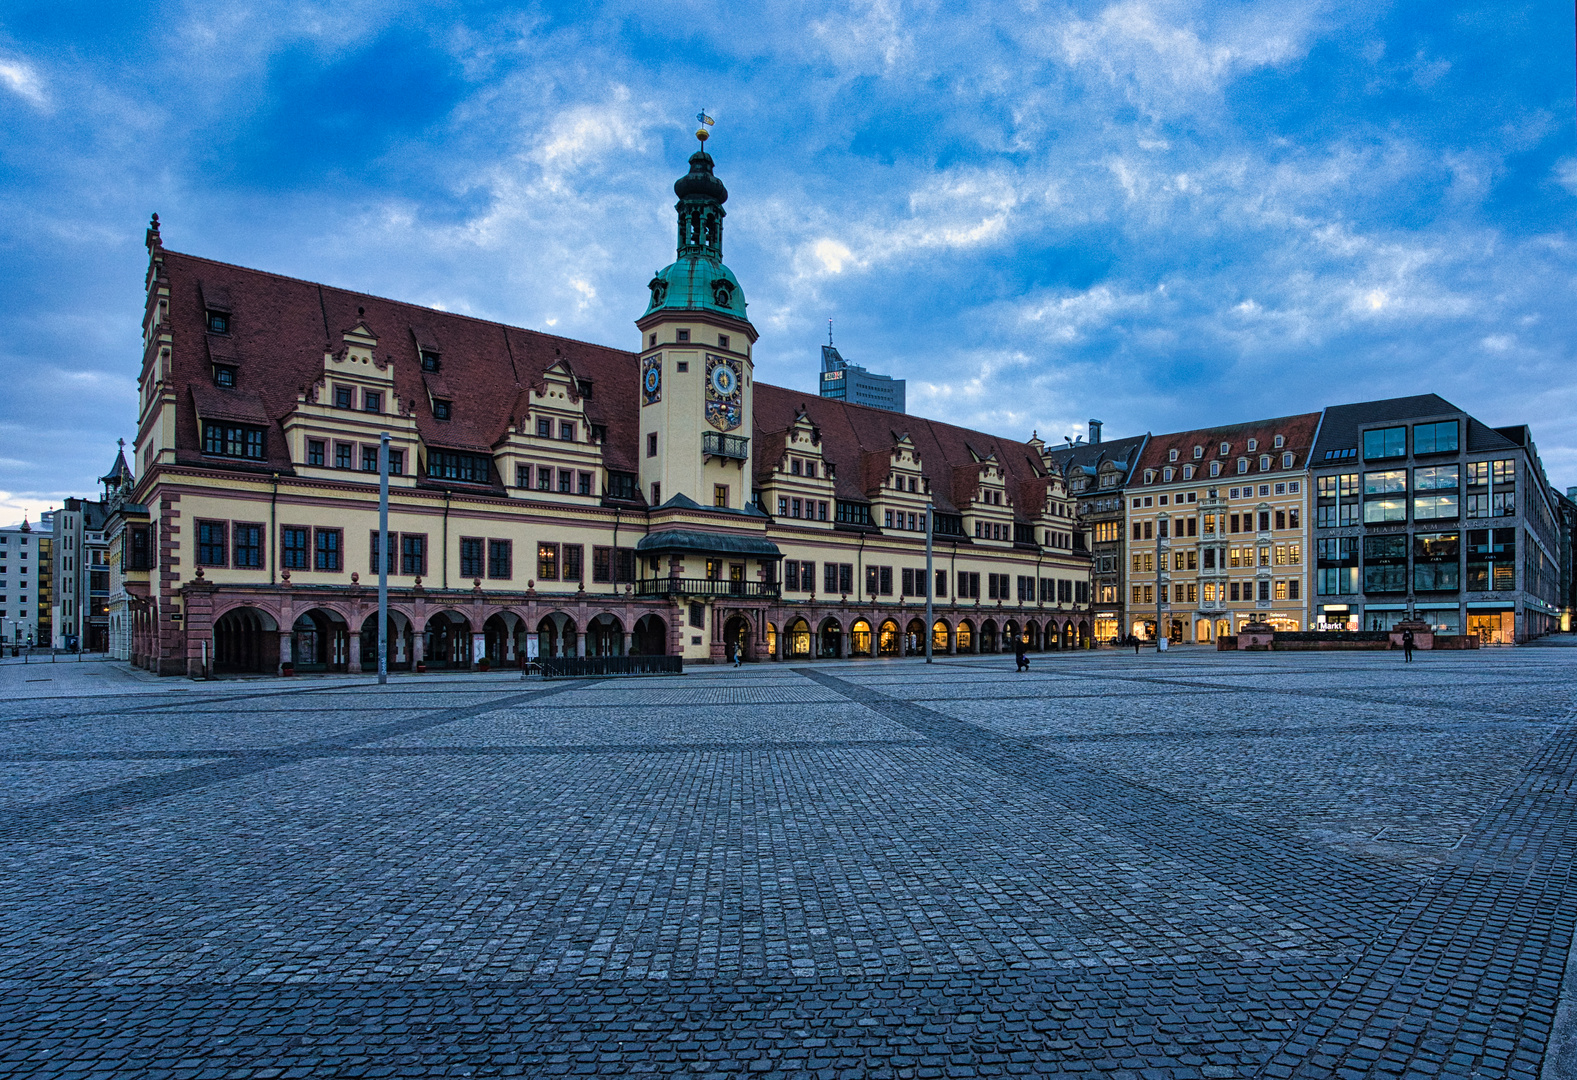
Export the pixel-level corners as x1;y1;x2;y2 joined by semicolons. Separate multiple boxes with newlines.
0;650;1577;1080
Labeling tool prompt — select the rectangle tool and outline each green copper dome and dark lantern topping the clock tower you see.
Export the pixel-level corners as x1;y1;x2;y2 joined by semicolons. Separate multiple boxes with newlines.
647;150;746;320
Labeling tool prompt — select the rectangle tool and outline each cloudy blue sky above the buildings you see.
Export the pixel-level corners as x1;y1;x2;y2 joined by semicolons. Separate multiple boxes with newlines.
0;0;1577;520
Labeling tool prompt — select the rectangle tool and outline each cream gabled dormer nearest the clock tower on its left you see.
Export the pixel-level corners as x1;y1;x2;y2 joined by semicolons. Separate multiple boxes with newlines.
494;358;607;503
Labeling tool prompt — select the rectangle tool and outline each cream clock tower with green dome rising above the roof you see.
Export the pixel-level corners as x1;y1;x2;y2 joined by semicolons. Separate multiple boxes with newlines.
636;128;757;511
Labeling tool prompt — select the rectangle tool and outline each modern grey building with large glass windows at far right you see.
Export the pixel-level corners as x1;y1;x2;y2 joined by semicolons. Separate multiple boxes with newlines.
1310;394;1561;645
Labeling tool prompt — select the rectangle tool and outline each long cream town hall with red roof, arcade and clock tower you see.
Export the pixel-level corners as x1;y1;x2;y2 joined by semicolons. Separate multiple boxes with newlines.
123;137;1093;673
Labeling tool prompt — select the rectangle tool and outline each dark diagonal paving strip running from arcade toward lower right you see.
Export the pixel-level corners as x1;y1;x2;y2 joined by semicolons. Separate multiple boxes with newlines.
795;668;1418;952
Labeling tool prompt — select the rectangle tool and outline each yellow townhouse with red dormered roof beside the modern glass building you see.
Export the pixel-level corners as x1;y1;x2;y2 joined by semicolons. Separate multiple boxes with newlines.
1126;413;1320;642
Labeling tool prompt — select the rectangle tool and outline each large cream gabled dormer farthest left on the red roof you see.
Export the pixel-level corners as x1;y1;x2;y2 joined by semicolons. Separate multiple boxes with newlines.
284;311;419;484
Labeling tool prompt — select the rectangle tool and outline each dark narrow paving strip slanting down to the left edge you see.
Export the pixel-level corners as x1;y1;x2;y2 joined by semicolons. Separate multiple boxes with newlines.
0;680;596;840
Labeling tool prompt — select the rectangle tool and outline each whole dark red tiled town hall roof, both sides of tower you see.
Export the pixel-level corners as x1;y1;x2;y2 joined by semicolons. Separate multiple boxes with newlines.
161;249;1047;516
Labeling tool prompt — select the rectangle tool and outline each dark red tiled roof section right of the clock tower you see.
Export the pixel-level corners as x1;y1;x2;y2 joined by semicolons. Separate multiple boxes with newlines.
755;383;1044;516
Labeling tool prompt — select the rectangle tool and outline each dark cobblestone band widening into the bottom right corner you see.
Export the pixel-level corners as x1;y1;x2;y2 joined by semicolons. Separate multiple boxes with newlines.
1258;712;1577;1080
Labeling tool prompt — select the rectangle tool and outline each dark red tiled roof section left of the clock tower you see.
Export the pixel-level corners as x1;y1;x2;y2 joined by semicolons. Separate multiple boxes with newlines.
162;251;639;471
